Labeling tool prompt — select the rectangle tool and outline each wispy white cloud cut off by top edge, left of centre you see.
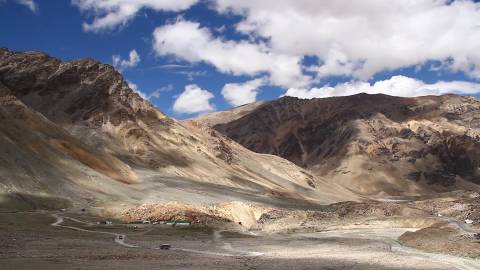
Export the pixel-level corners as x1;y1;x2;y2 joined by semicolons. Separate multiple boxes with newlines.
72;0;198;32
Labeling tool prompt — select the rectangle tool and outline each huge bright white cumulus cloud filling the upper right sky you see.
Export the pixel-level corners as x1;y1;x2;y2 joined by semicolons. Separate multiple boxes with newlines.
214;0;480;80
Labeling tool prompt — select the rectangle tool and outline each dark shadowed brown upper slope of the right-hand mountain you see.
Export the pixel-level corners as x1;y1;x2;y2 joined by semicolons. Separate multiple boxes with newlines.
214;94;450;167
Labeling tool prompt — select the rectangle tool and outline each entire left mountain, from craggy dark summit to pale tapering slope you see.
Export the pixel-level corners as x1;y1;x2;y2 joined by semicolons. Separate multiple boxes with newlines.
0;49;358;211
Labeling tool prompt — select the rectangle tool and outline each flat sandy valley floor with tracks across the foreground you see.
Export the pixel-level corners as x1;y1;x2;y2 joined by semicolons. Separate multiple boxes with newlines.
0;212;480;270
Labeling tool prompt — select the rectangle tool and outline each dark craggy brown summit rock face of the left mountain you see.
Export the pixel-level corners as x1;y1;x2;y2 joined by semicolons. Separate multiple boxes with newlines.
0;49;153;127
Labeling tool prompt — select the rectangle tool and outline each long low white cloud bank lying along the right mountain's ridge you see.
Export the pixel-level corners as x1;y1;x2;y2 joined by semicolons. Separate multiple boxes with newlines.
285;76;480;99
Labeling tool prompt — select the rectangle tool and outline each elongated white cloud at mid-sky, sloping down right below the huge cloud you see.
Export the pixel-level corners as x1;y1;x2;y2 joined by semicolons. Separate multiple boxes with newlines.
153;20;308;87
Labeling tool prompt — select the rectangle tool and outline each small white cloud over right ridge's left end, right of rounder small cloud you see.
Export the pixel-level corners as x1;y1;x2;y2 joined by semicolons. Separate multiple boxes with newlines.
222;79;265;107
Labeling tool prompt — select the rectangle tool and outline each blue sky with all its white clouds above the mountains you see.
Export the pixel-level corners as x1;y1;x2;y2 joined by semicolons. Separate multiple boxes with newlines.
0;0;480;118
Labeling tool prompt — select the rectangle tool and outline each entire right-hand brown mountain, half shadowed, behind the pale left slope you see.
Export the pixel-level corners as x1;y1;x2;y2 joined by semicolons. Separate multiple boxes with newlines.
199;94;480;197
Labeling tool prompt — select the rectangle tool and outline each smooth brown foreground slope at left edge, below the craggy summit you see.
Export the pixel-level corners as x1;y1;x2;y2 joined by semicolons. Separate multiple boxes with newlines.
0;80;142;208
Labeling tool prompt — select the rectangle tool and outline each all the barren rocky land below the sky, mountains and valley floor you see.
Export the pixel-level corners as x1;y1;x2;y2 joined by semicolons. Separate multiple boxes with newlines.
0;49;480;269
